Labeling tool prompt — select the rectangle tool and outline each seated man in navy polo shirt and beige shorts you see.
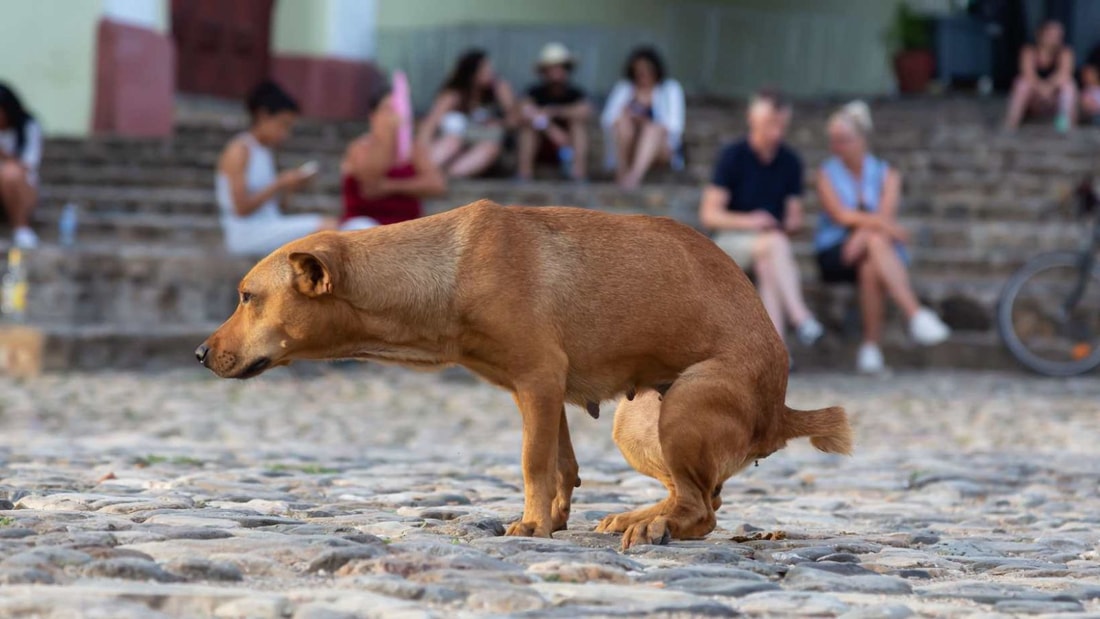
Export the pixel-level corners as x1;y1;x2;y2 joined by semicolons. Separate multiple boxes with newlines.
700;92;824;345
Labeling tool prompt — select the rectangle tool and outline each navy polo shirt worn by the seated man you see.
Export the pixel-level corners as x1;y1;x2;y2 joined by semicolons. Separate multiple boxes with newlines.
711;140;802;223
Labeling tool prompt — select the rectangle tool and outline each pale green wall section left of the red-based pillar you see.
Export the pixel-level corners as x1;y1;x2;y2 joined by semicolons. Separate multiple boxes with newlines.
0;0;103;135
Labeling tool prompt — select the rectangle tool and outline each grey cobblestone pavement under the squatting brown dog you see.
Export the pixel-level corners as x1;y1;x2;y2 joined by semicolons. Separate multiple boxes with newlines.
0;366;1100;619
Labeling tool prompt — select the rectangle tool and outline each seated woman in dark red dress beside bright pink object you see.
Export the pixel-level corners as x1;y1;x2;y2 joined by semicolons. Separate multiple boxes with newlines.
340;75;447;224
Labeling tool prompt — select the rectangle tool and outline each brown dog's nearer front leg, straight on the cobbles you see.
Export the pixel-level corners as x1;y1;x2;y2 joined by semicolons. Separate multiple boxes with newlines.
507;385;564;538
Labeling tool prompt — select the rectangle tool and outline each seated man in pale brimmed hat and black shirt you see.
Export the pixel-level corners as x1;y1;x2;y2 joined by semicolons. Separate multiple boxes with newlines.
518;43;592;180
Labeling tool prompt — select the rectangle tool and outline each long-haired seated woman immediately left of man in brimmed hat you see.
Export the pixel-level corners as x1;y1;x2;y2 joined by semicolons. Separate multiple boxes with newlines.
418;49;516;178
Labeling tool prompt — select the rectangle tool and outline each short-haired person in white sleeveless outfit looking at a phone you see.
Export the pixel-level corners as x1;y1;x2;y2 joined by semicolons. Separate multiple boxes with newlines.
215;81;375;255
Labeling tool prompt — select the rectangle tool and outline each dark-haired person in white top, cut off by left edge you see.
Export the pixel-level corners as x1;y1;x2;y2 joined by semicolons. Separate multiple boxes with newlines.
0;82;42;248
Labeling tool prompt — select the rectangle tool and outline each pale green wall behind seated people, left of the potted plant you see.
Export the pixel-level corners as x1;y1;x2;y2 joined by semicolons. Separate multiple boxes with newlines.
375;0;928;102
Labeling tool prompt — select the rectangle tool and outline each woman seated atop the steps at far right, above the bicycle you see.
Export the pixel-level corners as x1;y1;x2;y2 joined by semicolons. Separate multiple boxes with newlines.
1004;20;1077;131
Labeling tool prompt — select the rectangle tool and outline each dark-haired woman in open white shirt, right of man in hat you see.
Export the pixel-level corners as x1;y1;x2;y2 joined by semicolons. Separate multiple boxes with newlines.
600;47;684;189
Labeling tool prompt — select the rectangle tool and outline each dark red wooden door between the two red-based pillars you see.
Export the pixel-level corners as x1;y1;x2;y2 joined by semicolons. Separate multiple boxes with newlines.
172;0;275;99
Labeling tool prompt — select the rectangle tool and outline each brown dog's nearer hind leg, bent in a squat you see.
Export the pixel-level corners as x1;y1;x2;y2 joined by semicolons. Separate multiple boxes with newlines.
623;358;756;549
